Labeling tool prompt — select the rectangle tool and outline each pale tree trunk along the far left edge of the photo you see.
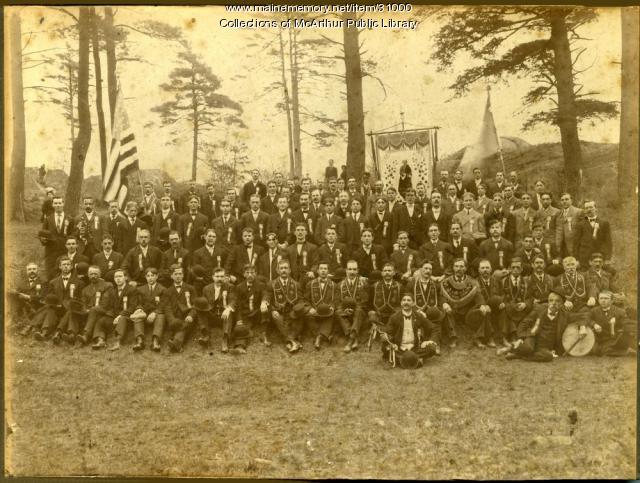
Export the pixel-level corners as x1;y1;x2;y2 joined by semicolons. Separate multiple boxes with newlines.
9;12;27;221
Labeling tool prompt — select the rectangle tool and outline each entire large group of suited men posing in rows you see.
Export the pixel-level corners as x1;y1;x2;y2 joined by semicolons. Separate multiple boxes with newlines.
14;166;636;364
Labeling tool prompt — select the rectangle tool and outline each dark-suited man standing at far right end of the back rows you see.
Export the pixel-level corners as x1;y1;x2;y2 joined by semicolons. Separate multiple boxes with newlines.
573;200;612;269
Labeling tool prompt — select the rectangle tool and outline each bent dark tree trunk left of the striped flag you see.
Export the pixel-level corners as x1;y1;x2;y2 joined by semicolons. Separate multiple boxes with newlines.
65;7;91;215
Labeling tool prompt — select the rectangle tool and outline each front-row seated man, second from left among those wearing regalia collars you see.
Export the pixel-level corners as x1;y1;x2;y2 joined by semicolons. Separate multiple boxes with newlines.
305;261;340;349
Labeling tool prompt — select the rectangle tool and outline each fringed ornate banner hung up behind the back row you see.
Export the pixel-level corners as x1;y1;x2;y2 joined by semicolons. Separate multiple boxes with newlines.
372;128;438;199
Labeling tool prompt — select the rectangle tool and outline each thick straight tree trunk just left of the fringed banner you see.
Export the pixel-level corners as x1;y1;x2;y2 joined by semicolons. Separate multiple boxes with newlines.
342;13;365;179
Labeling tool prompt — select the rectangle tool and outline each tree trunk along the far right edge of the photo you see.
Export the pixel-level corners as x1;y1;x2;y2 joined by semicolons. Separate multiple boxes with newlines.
618;7;640;201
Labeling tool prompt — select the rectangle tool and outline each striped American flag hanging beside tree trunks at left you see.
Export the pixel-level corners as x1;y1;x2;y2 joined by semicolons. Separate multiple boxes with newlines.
102;88;140;209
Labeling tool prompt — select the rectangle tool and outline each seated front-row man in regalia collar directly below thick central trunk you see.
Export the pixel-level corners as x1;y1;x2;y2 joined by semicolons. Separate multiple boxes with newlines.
337;260;369;351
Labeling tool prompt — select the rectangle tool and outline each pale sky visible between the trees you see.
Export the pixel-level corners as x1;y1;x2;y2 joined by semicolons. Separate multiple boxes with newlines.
5;6;620;181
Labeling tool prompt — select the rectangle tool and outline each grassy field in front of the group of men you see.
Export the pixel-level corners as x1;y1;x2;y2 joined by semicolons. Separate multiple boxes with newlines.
5;221;636;479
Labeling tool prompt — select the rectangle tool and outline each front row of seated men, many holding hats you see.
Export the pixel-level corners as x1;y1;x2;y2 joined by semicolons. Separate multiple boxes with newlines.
16;239;635;360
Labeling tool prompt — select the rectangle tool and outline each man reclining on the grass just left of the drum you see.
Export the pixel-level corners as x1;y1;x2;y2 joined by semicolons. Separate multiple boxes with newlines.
499;292;567;362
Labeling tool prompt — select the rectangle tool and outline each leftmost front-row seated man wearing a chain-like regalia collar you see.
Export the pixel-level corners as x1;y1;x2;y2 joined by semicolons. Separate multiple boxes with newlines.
267;260;304;353
